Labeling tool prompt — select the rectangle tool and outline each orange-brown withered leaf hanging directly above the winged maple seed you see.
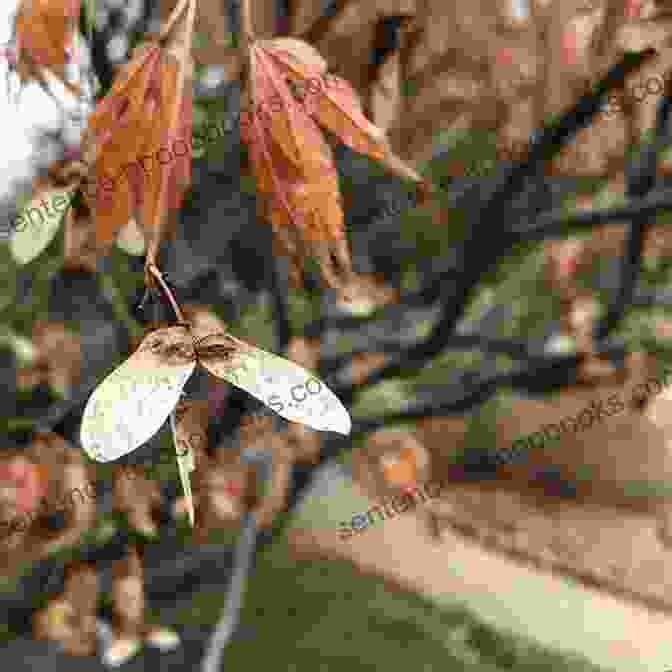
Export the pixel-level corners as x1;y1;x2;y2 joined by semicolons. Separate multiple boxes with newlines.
85;23;192;259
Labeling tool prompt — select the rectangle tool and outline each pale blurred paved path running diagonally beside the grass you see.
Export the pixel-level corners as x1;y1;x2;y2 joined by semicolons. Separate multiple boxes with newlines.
292;472;672;672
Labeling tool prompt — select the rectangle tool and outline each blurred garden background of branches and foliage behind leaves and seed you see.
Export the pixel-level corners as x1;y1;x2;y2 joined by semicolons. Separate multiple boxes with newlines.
0;0;672;672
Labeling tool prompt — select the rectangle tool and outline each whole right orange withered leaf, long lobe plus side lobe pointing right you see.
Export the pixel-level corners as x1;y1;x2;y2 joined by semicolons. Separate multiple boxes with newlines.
241;38;422;288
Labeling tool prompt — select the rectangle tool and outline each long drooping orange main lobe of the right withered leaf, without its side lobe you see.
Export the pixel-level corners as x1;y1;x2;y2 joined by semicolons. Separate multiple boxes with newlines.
241;54;351;287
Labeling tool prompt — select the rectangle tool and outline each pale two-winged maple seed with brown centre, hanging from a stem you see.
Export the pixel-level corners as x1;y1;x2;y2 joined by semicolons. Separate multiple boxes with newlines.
81;326;351;461
